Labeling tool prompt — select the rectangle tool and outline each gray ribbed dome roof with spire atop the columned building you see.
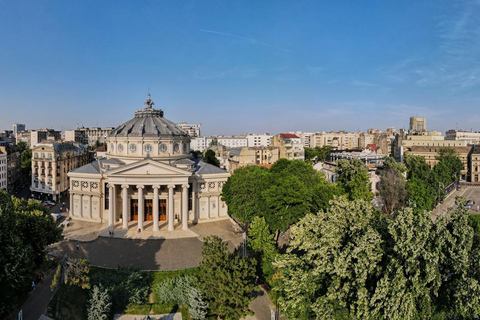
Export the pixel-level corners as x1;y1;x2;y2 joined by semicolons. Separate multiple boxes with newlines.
109;94;188;137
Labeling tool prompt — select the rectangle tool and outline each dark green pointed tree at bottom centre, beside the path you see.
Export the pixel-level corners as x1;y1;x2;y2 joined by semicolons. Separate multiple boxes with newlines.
198;236;256;320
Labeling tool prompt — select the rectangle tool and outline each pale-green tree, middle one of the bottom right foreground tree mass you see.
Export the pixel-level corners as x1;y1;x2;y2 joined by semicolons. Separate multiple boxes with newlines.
370;208;442;320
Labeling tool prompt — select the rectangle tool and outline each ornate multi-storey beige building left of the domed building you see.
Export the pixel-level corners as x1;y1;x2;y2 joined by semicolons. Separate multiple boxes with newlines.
30;141;89;200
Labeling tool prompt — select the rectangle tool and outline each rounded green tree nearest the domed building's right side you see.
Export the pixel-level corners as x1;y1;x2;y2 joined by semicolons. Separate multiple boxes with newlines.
222;166;268;230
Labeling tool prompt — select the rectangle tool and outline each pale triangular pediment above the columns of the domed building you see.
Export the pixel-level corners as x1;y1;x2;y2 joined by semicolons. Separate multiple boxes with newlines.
107;159;192;177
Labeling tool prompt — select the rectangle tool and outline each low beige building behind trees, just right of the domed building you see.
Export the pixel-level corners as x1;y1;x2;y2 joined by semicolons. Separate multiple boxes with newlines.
228;147;280;173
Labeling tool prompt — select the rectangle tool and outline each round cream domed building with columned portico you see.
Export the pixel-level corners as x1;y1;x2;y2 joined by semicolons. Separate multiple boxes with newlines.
68;94;229;231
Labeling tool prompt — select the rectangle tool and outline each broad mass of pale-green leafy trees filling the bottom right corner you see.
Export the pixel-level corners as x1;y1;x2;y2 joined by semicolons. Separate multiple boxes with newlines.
275;197;480;319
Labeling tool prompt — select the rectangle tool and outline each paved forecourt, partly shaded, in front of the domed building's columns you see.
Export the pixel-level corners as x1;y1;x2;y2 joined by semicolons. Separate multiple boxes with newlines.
49;219;242;270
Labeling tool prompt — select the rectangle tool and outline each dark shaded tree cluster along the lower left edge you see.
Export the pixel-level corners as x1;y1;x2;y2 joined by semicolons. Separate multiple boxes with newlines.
0;190;62;315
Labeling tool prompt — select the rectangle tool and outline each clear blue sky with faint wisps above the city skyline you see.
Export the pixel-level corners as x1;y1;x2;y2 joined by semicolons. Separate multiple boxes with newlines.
0;0;480;134
